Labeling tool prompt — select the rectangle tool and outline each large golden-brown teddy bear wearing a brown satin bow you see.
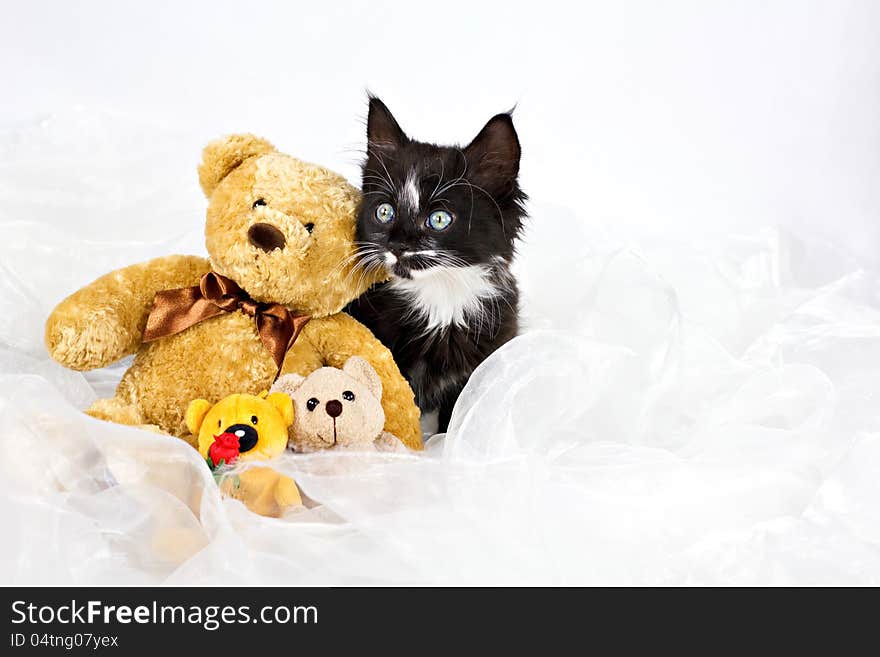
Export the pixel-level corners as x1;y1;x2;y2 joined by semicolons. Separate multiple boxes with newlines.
46;135;421;449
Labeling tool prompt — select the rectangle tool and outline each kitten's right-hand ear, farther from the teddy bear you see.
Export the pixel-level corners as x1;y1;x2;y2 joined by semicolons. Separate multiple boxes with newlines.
464;113;520;193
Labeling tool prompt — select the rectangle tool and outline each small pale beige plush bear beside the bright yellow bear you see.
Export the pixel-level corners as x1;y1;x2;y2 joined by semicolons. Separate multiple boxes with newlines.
272;356;404;452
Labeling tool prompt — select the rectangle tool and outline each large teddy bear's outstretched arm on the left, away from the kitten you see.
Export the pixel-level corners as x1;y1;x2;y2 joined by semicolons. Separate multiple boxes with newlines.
46;256;210;370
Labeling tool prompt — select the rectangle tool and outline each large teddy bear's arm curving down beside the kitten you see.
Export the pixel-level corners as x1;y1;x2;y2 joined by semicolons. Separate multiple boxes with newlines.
298;313;422;449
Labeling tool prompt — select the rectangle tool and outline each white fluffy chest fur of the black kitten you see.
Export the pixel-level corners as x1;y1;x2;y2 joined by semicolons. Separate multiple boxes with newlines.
389;265;499;331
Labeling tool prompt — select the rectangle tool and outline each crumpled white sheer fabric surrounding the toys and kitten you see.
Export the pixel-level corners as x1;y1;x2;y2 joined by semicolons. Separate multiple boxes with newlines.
0;111;880;584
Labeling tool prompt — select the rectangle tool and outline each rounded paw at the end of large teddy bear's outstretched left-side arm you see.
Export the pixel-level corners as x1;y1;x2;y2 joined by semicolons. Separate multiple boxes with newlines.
46;309;131;371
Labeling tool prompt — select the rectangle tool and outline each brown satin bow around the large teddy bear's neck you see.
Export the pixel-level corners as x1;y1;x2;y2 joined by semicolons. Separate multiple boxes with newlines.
143;272;311;370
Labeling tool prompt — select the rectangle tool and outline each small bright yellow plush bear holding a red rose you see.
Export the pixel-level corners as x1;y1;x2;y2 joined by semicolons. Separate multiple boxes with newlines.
186;392;303;518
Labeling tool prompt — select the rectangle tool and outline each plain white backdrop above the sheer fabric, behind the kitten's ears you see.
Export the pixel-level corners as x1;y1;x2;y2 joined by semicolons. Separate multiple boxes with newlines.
0;0;880;262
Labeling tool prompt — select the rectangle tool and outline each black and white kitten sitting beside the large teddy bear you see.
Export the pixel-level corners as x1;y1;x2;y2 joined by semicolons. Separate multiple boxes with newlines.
348;93;526;432
